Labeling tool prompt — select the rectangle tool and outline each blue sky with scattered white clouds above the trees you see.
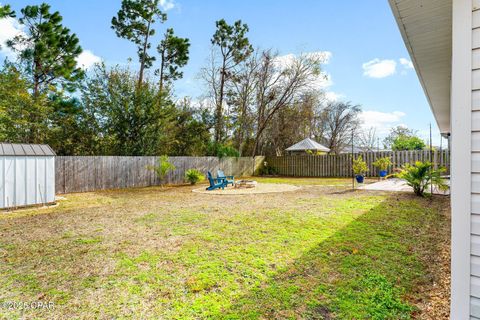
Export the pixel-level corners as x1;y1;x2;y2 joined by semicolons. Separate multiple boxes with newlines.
0;0;438;144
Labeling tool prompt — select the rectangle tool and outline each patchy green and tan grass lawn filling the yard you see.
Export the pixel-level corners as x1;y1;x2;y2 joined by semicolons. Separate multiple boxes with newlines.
0;178;449;319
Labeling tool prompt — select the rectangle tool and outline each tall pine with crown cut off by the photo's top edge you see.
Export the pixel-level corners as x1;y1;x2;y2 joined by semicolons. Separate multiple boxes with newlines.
112;0;167;86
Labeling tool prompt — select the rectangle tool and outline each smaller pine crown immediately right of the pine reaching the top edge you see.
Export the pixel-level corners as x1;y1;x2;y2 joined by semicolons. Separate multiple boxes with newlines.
157;28;190;93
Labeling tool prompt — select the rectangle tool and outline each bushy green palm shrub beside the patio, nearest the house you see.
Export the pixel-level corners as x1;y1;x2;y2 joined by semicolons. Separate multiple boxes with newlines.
397;161;448;197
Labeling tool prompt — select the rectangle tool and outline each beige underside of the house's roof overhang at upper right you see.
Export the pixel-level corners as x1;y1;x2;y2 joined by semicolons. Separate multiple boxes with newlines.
389;0;452;133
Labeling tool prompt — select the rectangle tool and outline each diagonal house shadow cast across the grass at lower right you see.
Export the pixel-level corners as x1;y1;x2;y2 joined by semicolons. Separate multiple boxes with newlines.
220;191;449;320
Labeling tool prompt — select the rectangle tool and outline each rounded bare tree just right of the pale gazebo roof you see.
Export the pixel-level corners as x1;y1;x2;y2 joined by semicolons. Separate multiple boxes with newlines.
319;102;361;154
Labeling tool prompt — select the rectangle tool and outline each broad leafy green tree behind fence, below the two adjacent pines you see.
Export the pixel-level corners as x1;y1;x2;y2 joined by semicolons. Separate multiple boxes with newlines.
82;65;175;155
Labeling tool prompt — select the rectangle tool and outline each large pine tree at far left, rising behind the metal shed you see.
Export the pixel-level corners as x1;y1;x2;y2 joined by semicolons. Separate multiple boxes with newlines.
7;3;83;143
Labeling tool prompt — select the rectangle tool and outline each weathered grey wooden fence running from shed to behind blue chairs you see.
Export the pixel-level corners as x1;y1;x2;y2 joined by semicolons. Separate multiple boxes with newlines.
55;156;264;193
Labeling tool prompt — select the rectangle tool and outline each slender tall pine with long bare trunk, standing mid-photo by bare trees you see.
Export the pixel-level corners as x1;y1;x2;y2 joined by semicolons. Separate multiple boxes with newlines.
211;19;253;144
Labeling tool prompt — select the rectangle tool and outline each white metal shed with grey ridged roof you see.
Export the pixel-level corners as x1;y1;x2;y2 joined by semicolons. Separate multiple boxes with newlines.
0;143;55;209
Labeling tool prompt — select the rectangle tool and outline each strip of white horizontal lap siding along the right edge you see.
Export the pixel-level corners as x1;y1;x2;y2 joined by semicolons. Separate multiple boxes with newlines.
470;0;480;319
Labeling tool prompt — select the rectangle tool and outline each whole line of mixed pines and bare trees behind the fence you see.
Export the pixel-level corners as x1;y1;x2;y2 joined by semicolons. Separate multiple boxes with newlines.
0;0;361;156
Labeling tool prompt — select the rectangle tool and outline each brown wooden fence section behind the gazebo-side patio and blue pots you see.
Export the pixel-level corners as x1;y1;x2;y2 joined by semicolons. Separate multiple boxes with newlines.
265;150;450;177
